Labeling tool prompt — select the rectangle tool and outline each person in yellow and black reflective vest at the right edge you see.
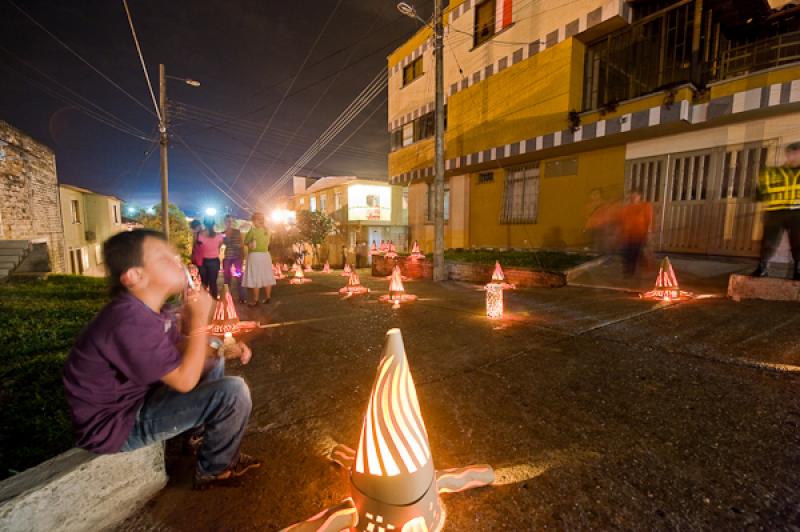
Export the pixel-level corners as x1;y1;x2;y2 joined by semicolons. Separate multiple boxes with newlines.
753;142;800;281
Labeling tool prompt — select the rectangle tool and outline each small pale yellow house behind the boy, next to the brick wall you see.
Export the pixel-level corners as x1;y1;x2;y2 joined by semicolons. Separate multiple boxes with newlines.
59;185;127;275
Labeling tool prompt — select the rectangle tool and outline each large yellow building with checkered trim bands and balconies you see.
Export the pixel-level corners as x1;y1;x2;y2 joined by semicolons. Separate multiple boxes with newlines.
388;0;800;262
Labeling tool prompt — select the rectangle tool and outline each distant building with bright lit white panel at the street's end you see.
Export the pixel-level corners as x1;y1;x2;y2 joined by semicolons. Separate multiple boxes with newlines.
286;176;408;266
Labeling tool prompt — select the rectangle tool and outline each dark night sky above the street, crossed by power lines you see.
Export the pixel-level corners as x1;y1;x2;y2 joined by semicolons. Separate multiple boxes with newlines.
0;0;432;214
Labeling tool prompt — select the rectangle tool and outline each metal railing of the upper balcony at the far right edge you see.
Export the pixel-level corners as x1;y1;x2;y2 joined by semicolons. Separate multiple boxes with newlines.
715;31;800;80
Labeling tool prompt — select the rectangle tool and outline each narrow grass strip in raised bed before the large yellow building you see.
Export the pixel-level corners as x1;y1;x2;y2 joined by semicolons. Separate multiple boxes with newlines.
428;249;595;272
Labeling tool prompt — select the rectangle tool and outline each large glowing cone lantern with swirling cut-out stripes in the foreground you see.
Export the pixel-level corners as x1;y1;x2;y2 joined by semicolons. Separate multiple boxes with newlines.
285;329;495;532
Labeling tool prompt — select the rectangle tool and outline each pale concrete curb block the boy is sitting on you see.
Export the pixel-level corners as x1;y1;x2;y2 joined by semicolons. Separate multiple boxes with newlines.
0;443;167;532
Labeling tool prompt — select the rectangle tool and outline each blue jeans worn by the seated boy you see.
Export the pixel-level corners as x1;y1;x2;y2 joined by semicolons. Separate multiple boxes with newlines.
120;358;252;475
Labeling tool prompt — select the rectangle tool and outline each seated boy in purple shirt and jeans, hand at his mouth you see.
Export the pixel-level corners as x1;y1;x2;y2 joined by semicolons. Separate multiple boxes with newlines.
64;229;261;489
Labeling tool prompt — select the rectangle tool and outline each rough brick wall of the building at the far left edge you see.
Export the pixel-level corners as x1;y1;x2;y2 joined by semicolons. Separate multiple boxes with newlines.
0;120;65;272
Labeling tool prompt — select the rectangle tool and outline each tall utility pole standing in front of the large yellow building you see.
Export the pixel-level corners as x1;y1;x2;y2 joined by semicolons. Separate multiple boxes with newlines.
433;0;447;281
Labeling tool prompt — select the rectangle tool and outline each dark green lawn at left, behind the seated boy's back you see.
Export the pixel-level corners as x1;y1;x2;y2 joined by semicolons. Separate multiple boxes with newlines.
0;275;108;479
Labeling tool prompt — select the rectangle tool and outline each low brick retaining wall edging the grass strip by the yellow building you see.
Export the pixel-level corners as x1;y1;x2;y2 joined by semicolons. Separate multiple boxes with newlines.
372;256;567;288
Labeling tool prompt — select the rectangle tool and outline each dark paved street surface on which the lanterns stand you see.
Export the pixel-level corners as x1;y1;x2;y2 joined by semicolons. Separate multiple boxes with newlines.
119;272;800;531
